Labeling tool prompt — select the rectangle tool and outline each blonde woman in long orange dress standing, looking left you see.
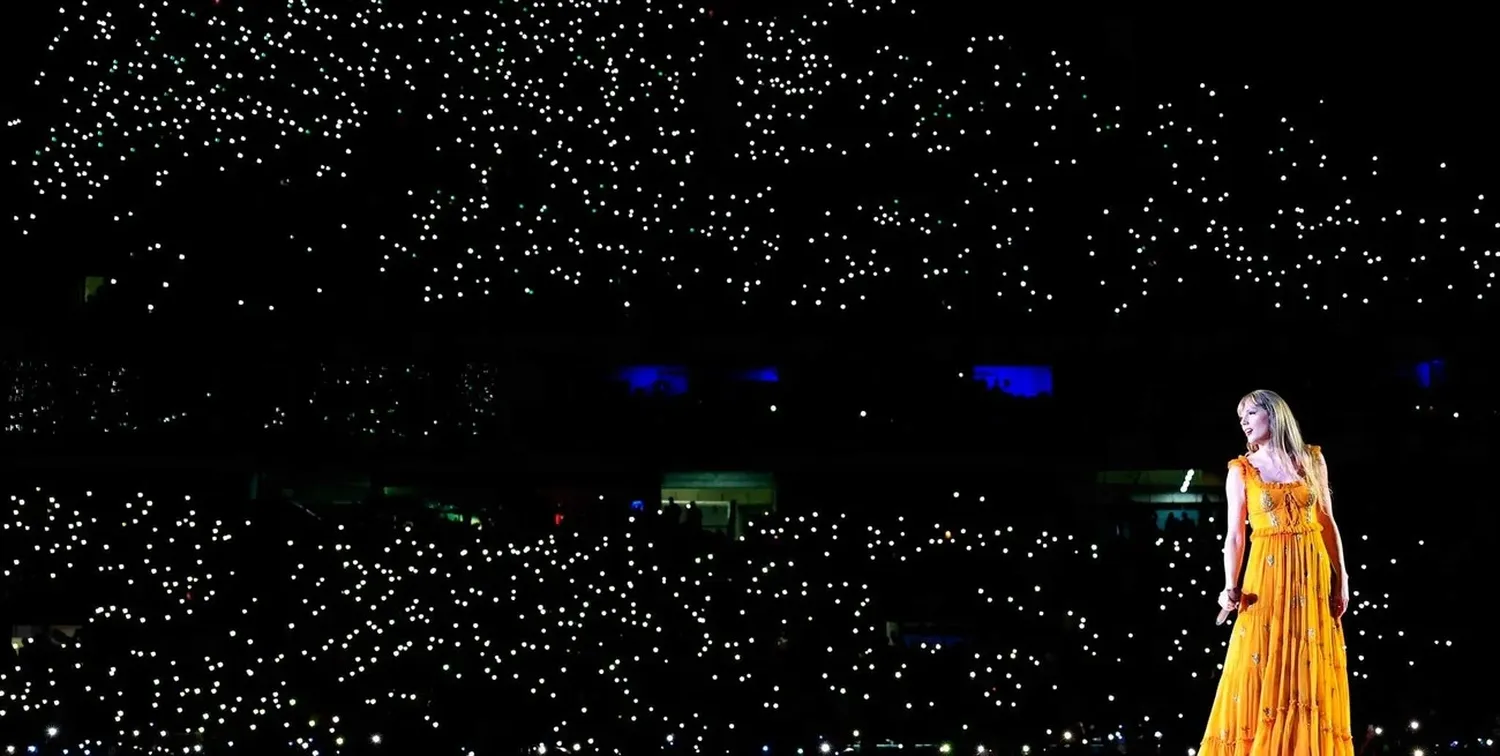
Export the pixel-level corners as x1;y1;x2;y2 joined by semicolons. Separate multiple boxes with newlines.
1199;390;1355;756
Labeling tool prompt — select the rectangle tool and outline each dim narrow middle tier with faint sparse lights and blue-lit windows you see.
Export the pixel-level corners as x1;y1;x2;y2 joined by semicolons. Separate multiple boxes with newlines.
0;360;1497;441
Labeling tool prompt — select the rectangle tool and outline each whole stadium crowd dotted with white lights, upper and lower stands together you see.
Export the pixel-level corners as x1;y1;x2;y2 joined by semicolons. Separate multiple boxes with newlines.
0;0;1500;756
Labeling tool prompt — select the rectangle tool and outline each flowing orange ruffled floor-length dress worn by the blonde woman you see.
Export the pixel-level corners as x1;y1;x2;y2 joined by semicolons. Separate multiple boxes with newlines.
1199;446;1355;756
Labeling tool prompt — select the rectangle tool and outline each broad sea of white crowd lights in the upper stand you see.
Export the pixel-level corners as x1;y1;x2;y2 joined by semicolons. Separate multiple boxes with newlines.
8;0;1500;315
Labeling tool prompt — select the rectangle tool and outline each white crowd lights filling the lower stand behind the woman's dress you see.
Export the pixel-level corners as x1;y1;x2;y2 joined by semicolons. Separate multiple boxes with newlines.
0;488;1485;753
